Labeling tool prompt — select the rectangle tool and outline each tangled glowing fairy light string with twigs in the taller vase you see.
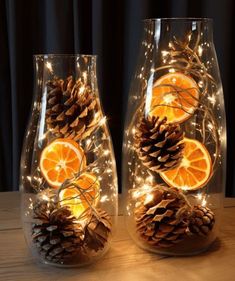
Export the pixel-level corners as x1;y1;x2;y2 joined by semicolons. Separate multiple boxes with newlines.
125;32;221;201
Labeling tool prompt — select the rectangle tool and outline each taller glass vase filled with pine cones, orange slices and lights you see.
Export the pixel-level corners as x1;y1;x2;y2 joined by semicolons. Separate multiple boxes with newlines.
123;19;226;255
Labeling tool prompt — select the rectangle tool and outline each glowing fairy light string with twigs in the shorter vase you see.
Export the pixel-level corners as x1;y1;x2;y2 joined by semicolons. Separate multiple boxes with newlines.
26;69;113;224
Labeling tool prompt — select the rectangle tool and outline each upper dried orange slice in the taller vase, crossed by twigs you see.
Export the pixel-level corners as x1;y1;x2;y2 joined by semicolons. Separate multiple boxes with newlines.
149;72;199;123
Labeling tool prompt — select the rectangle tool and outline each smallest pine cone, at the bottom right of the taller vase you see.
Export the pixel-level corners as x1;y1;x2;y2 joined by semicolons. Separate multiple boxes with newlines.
189;205;215;236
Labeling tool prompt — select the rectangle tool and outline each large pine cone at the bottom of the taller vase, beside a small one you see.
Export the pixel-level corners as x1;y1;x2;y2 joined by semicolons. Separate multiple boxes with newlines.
134;186;190;247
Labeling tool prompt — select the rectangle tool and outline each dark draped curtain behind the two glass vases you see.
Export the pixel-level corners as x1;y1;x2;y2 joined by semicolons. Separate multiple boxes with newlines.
0;0;235;196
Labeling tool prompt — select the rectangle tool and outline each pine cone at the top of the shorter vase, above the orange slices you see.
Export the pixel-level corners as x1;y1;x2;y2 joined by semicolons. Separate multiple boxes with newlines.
46;76;101;141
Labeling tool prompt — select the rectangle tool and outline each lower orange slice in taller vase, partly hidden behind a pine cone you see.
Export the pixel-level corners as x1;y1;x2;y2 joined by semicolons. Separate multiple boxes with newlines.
160;138;212;190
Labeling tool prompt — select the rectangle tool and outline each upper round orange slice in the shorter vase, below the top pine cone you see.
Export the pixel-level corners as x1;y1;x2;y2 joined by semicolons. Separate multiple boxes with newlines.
40;139;86;187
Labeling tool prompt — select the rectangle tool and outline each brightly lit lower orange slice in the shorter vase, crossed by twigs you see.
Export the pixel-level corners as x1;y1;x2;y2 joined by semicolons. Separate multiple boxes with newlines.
60;173;100;217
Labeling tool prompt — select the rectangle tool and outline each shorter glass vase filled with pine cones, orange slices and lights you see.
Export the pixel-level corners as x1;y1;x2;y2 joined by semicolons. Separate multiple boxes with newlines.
20;55;117;266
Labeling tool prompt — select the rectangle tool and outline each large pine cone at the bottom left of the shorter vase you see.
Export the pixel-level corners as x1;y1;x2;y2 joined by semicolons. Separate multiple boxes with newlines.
32;201;84;264
